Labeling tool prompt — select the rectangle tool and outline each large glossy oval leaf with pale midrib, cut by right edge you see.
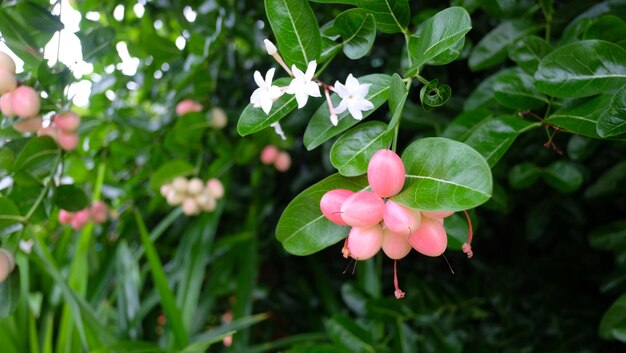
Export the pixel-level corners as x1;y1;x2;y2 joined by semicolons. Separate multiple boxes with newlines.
535;40;626;98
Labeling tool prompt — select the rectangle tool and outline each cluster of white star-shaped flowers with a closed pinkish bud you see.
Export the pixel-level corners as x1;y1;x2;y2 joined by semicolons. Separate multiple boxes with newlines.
250;39;374;126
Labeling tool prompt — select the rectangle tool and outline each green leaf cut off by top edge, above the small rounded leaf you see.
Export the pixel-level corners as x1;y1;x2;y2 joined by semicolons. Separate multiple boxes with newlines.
357;0;410;33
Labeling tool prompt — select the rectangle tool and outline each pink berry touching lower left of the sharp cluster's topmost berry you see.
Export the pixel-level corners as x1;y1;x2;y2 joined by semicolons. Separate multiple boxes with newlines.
340;191;385;228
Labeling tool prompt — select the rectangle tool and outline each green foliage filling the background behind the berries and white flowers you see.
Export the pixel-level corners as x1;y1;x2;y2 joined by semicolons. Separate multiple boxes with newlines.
0;0;626;353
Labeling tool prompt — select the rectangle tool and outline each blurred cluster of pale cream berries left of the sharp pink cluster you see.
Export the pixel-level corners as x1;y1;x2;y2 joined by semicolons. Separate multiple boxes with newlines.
161;177;224;216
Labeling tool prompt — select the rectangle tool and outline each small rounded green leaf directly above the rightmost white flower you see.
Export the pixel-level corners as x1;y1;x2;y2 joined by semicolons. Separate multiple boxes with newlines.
333;8;376;60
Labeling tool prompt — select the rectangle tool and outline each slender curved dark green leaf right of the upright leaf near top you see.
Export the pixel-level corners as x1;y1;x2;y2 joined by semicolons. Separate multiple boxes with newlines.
468;19;539;71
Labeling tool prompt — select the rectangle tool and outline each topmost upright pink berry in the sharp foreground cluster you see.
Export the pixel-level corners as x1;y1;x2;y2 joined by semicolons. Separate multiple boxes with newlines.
367;150;406;197
